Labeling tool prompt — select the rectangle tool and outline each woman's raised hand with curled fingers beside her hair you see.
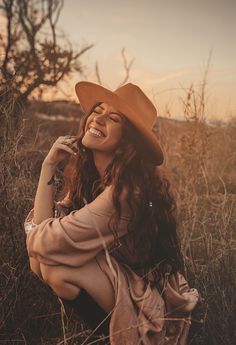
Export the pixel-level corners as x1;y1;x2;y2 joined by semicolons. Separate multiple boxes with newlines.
43;135;78;166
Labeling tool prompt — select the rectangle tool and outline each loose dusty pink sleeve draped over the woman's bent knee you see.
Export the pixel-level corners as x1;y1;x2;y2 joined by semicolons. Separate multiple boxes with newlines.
26;186;131;267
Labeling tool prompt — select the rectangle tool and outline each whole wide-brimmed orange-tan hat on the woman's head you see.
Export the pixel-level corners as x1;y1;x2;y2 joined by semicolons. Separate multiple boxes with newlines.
75;81;164;165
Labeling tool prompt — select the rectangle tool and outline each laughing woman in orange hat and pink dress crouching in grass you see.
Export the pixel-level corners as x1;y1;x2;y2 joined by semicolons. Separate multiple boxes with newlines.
25;82;198;345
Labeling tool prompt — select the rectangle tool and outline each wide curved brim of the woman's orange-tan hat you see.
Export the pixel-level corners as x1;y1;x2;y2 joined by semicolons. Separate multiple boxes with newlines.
75;81;164;165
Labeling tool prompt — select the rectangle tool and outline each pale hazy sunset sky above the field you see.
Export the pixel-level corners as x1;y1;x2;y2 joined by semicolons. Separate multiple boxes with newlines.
1;0;236;119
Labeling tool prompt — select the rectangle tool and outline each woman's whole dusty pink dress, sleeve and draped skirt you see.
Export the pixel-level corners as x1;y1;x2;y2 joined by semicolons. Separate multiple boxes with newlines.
24;187;195;345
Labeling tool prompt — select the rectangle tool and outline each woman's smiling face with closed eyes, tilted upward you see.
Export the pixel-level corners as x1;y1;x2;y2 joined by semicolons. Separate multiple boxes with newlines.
82;103;124;153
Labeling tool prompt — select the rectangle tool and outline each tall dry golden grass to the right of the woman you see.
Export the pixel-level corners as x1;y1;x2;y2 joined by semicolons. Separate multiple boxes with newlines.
159;81;236;345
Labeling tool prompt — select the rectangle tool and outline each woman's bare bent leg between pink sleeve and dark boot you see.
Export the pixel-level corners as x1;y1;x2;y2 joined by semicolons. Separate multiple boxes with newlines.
40;259;115;313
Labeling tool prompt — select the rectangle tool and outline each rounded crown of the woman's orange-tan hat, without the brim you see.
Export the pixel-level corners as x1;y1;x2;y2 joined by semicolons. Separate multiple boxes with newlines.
114;83;157;129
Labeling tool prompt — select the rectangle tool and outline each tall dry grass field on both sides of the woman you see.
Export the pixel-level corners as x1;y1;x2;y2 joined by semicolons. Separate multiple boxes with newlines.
0;80;236;345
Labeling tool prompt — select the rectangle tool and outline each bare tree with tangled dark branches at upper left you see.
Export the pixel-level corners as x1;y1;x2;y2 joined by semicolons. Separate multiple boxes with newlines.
0;0;93;100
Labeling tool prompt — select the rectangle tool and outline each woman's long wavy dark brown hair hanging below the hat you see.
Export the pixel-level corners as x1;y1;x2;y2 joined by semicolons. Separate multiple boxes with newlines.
58;104;183;286
